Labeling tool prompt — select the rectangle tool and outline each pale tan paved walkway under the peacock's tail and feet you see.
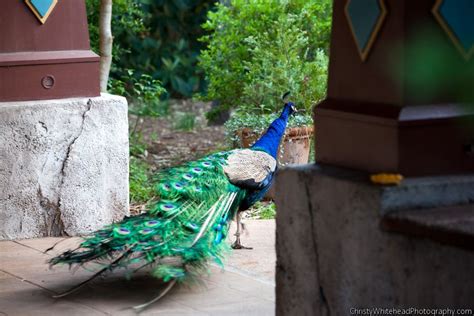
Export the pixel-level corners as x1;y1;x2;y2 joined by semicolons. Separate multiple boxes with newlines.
0;220;275;316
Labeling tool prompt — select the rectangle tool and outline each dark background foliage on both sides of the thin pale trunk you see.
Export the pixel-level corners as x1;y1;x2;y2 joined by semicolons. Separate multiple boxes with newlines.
87;0;215;98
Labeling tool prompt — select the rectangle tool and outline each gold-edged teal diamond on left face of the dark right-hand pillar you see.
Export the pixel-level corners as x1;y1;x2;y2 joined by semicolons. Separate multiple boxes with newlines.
347;0;382;51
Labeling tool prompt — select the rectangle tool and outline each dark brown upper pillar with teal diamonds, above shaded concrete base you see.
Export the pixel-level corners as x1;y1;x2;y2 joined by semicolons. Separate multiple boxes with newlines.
315;0;474;176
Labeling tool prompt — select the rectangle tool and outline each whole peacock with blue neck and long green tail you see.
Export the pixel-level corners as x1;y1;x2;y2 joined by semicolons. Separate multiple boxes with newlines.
49;97;296;310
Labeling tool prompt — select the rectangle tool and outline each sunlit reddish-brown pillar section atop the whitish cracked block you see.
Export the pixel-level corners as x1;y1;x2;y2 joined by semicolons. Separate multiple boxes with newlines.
0;0;100;102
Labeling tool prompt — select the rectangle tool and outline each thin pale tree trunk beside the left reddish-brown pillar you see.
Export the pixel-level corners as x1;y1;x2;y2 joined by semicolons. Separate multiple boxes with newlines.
99;0;114;92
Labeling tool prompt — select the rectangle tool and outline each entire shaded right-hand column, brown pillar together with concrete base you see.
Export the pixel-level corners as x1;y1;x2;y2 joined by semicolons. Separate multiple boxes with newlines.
276;0;474;315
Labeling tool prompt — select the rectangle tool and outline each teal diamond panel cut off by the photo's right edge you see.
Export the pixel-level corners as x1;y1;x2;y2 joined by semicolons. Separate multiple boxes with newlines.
439;0;474;52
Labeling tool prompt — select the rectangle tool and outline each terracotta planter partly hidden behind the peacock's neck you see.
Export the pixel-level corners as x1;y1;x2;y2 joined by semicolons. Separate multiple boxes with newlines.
237;126;313;200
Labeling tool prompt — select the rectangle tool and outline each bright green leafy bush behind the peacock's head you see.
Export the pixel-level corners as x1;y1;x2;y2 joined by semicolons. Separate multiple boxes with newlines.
200;0;331;115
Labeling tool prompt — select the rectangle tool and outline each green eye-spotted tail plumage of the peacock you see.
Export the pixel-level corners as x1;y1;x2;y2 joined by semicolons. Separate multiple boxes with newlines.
50;152;246;281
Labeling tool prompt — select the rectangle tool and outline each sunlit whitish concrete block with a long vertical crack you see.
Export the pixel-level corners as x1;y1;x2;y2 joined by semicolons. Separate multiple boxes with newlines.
0;94;129;239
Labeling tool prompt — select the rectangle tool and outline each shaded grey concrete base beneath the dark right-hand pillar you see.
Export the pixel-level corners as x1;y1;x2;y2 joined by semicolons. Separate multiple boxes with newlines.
276;165;474;315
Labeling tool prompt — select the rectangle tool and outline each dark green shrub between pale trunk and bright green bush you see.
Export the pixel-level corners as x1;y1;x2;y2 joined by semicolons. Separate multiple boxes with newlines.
114;0;214;97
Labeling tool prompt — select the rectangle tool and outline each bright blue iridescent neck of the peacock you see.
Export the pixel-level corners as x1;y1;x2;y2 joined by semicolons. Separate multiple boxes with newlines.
251;103;292;159
